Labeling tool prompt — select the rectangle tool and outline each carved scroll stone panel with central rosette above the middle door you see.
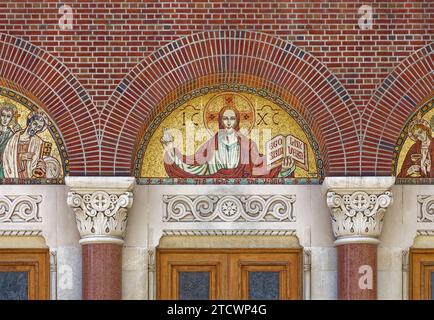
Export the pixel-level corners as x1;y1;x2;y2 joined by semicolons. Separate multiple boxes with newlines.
163;194;296;222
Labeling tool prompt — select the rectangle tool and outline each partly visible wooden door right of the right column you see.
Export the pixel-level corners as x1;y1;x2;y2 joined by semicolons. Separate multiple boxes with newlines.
410;249;434;300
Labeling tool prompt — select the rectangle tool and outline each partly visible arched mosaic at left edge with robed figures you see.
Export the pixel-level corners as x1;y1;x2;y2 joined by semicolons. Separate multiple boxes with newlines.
0;87;69;184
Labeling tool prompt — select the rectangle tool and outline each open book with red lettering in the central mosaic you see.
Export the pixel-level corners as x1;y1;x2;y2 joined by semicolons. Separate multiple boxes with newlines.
265;135;309;171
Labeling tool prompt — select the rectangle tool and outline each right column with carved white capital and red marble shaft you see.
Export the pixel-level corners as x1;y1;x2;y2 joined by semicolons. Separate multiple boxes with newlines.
324;177;395;300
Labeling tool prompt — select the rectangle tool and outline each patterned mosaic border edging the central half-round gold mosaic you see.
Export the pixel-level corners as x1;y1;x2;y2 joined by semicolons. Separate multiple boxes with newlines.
134;84;324;185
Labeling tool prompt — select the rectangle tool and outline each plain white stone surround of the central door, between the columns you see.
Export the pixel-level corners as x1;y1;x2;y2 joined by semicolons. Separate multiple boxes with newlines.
123;185;337;299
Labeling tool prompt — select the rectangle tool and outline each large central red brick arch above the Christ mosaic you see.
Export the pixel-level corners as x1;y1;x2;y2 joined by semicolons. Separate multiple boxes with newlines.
101;31;360;175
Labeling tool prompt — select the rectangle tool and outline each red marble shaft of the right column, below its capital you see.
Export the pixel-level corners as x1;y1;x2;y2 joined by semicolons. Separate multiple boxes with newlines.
337;243;377;300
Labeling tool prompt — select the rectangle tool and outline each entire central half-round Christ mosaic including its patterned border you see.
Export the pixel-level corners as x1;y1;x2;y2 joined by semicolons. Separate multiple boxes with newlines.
134;85;323;184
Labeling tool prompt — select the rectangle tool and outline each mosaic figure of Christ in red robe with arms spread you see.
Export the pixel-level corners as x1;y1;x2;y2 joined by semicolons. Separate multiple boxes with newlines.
161;100;295;178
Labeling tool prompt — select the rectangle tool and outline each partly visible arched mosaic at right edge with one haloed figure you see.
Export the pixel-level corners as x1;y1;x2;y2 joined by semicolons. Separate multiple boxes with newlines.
392;96;434;184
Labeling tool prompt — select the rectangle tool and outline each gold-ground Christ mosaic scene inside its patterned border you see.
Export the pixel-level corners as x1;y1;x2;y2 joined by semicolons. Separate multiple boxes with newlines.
142;92;316;179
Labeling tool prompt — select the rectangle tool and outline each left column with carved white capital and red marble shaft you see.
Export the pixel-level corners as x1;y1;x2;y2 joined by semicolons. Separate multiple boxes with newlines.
66;177;135;300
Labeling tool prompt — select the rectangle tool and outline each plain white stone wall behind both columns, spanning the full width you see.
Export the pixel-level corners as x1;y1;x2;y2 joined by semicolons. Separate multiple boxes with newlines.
0;185;434;299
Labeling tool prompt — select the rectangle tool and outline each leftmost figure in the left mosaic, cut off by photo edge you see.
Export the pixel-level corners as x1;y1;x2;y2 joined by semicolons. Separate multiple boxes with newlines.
0;102;21;179
